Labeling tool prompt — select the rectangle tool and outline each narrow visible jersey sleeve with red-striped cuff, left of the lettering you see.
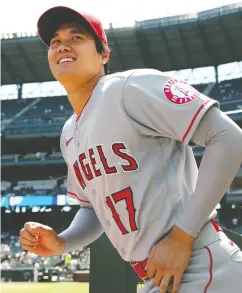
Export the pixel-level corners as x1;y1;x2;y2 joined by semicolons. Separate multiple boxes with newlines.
60;126;92;208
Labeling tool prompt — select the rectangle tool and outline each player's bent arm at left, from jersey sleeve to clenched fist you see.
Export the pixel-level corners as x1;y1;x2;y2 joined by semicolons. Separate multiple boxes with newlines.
20;120;103;256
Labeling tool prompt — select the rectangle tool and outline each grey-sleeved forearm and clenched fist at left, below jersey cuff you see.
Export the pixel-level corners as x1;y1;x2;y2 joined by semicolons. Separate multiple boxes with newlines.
20;208;103;256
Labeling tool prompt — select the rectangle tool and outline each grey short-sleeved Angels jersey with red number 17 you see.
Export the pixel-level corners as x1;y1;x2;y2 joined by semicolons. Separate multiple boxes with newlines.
61;69;217;261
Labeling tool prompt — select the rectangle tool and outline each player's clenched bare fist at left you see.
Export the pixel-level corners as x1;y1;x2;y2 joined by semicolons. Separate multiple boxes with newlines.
20;222;65;256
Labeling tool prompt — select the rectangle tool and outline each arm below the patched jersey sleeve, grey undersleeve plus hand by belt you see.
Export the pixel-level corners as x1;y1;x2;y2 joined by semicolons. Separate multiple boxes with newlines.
152;107;242;293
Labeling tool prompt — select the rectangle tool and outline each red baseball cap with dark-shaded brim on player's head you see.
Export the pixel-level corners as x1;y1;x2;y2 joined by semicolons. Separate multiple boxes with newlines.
37;6;110;53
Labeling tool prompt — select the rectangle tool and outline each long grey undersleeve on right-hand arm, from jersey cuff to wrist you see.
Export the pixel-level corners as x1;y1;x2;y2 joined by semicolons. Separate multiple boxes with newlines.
177;108;242;237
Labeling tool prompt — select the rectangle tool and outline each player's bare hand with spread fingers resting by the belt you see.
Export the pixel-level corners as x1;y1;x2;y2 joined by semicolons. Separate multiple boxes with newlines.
146;226;195;293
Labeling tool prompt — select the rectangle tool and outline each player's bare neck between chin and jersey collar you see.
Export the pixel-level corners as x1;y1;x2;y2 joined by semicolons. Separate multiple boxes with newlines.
65;74;103;115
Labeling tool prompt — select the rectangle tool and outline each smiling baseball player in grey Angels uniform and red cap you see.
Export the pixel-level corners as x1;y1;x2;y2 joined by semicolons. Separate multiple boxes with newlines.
20;7;242;293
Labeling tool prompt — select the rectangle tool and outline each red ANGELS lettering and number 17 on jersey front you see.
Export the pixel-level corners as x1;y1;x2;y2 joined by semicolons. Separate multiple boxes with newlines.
73;143;138;235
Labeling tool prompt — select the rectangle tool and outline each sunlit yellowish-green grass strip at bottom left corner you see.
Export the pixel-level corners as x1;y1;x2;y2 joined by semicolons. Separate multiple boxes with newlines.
1;282;89;293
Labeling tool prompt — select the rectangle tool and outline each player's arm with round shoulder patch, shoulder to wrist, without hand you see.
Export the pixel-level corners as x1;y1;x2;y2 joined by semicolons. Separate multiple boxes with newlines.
123;69;242;238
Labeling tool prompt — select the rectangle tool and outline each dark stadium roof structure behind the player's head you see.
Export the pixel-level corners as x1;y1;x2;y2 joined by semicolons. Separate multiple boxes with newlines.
2;2;242;85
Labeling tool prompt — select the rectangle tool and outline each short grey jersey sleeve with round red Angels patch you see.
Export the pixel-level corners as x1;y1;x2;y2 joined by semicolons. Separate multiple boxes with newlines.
123;69;219;144
